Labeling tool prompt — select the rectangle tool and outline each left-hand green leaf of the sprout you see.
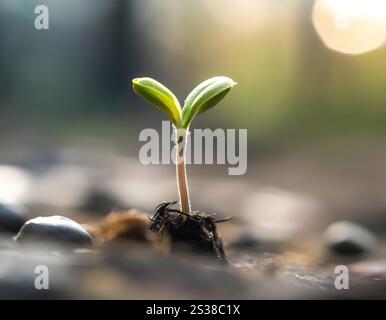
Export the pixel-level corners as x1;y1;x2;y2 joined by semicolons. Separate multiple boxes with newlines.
133;78;182;128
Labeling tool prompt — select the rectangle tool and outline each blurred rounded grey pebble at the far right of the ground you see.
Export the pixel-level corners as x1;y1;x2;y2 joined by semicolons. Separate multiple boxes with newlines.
325;221;377;255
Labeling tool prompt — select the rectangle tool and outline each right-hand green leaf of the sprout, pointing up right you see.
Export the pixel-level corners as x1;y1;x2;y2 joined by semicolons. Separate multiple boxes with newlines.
182;76;236;128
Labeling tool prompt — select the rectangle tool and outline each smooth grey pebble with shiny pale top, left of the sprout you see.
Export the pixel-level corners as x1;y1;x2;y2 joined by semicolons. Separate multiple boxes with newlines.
16;216;93;248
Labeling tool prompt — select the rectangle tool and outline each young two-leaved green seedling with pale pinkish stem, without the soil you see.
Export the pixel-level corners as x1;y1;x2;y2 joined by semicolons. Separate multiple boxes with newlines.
133;76;236;215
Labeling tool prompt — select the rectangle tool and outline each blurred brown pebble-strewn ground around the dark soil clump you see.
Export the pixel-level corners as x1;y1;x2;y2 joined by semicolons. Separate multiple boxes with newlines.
0;145;386;299
